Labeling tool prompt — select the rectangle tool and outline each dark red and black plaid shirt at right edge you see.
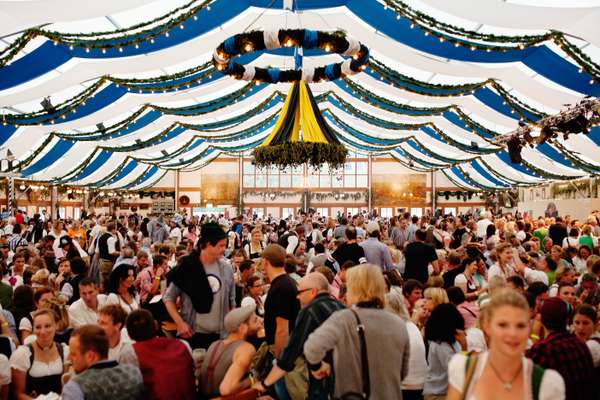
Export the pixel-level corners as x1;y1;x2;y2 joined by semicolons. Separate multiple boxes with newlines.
527;331;597;400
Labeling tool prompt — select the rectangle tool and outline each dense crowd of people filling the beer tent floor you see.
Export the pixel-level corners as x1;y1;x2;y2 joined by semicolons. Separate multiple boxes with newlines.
0;211;600;400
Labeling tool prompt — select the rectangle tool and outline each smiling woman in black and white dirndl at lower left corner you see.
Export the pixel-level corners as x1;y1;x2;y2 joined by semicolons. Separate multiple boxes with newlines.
10;309;69;400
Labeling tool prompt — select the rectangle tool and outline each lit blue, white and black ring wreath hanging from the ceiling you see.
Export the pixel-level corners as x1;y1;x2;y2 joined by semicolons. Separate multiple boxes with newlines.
213;29;369;83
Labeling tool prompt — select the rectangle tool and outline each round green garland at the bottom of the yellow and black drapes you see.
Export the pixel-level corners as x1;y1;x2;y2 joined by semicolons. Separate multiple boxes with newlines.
252;142;348;169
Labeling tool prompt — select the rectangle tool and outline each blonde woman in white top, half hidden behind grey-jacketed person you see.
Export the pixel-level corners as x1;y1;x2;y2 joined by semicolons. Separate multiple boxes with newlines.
385;289;427;400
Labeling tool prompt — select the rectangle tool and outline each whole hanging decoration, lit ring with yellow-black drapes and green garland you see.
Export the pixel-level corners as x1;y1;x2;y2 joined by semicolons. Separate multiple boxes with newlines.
213;29;369;169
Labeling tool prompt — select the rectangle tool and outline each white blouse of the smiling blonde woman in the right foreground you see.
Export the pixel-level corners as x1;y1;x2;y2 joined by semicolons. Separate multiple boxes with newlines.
448;351;565;400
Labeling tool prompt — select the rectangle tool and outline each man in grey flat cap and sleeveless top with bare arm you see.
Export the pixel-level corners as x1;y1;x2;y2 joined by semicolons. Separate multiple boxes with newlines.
198;305;262;398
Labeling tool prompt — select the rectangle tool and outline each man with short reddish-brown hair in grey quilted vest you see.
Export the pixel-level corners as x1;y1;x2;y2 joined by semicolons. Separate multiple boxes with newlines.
62;325;144;400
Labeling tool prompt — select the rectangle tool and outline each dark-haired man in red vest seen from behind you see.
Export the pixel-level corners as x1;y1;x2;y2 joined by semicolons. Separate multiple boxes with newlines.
123;309;196;400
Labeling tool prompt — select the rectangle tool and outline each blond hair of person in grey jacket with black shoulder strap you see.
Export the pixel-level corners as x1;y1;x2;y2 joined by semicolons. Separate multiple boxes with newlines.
346;264;385;307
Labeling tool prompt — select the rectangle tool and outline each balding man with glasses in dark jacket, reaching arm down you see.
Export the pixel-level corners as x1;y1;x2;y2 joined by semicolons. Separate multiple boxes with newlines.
254;272;345;399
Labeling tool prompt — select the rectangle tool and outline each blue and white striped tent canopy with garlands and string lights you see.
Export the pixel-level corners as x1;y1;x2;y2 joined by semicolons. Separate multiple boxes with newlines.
0;0;600;190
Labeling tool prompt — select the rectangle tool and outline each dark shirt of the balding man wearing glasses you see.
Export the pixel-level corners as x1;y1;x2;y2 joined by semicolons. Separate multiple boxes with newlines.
277;293;346;372
